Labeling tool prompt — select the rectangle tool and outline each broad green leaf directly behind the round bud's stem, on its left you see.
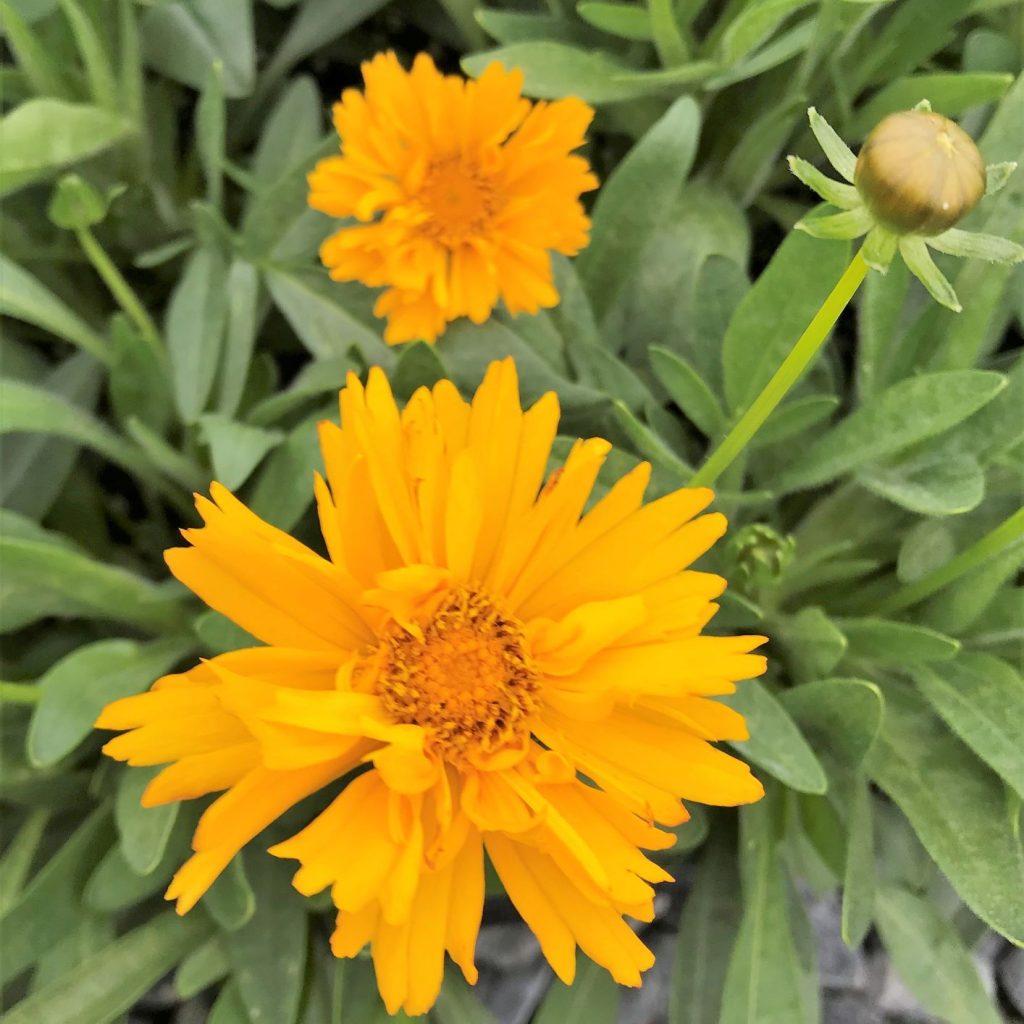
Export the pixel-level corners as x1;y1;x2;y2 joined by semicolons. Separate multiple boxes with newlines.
722;231;849;412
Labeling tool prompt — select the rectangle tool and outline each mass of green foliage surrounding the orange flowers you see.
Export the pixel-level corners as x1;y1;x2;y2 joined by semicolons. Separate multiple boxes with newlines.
0;0;1024;1024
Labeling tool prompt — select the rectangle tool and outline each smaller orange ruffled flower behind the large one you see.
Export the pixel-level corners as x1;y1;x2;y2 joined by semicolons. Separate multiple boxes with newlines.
309;53;597;344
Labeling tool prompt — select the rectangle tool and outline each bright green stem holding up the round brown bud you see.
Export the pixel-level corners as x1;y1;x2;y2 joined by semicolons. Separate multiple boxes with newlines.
688;252;867;487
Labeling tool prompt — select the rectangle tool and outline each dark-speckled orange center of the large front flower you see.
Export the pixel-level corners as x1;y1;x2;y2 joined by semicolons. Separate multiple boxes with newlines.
376;587;539;761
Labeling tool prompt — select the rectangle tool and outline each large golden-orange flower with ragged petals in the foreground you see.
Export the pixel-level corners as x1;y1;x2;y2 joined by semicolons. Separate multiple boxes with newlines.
97;360;765;1014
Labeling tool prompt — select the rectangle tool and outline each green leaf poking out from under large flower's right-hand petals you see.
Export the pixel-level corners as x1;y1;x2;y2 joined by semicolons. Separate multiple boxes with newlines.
719;679;828;793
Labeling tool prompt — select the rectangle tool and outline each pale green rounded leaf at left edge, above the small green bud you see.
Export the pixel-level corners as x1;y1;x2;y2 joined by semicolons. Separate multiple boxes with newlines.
0;98;132;194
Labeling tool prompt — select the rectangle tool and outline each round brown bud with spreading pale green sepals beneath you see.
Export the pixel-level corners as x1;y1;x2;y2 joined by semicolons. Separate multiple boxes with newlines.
790;100;1024;312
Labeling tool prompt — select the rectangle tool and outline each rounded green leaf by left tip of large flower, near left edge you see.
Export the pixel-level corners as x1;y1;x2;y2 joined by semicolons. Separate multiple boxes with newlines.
28;638;191;768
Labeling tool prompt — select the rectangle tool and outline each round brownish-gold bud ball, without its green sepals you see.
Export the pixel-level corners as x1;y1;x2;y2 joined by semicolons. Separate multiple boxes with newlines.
854;110;985;236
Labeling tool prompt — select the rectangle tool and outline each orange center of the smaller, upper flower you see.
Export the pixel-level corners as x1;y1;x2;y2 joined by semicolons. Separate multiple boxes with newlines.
419;157;498;247
